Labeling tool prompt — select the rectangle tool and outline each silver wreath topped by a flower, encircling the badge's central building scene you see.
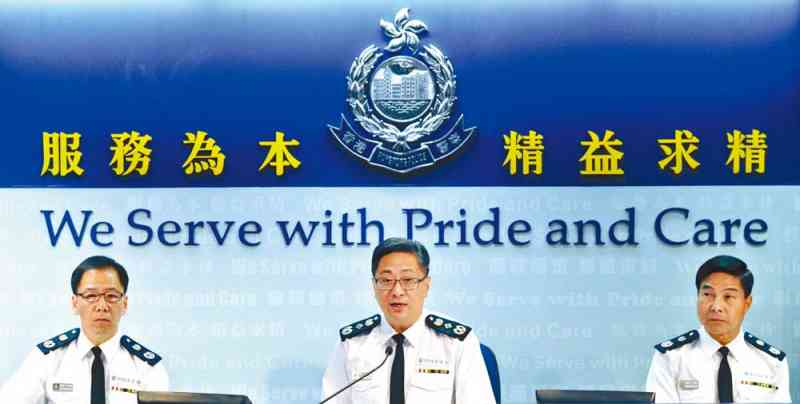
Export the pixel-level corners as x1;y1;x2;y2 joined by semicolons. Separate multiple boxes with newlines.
347;8;456;151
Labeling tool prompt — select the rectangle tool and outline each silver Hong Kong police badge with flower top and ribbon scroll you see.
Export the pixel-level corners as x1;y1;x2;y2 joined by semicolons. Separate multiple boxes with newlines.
328;8;477;173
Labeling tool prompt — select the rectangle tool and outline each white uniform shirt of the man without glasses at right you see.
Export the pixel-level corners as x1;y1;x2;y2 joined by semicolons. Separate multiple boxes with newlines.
647;329;792;403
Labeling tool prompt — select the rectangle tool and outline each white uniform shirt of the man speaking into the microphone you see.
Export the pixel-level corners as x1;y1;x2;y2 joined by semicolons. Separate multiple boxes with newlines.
322;312;495;404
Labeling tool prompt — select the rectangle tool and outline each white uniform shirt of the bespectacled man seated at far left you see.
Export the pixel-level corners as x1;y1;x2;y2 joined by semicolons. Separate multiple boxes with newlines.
0;333;169;404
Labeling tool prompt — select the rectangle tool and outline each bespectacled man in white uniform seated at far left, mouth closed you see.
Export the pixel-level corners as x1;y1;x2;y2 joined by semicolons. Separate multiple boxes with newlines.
0;256;169;404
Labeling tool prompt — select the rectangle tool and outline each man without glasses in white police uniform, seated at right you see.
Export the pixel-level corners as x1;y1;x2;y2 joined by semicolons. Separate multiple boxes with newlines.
647;255;791;403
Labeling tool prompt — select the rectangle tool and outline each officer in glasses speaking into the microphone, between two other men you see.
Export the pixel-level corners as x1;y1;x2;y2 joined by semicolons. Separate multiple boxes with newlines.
322;238;495;404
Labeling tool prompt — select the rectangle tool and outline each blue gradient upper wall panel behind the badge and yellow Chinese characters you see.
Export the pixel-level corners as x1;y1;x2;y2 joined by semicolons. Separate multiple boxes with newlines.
0;1;800;187
